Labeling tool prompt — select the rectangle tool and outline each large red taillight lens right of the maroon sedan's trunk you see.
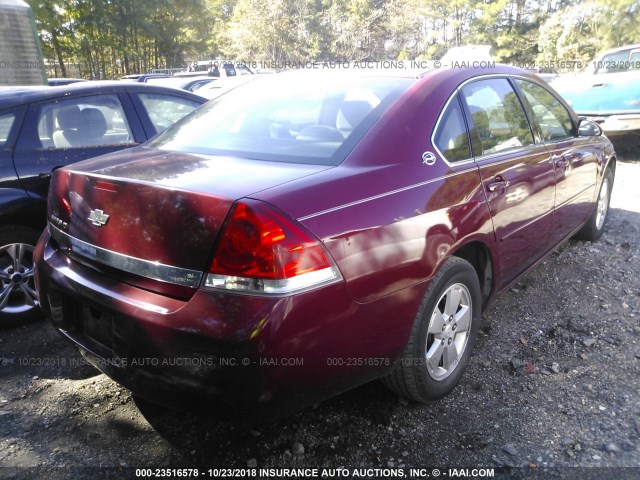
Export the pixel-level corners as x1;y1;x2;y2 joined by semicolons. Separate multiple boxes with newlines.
209;201;332;280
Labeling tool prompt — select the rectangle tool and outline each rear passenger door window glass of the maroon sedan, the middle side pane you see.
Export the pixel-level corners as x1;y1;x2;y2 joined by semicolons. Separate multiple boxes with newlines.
462;78;533;155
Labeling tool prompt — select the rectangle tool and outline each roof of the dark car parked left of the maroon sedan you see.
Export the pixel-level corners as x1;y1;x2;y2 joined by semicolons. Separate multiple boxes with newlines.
0;80;206;108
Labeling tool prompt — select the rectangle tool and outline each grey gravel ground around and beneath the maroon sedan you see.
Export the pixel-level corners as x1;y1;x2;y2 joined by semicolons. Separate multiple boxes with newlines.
0;141;640;479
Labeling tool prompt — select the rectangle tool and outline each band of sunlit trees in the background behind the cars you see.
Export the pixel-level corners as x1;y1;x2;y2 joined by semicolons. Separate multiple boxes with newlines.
28;0;640;78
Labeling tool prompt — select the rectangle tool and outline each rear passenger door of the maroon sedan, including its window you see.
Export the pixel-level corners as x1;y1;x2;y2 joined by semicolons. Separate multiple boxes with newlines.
460;77;555;288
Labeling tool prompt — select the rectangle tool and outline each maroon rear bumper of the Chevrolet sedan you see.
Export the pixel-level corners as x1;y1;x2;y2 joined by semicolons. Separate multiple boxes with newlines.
35;232;413;421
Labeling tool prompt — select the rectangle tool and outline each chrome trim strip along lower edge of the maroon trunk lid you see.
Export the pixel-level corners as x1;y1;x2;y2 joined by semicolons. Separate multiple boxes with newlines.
49;222;203;288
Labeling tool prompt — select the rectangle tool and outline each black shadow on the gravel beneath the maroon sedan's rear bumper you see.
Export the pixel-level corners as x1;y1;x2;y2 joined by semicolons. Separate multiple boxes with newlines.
134;382;408;467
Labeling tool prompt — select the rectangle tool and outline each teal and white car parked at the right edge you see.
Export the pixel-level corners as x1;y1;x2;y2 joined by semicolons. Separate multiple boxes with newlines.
552;44;640;137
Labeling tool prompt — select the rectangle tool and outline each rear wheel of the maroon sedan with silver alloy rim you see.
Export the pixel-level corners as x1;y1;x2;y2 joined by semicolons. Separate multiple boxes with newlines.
383;257;481;403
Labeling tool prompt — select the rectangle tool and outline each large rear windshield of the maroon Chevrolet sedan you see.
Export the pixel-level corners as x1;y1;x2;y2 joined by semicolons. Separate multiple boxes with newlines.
148;73;414;165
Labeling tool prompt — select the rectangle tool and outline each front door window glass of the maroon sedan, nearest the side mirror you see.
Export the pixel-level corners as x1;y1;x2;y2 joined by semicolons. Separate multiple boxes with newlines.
516;80;574;142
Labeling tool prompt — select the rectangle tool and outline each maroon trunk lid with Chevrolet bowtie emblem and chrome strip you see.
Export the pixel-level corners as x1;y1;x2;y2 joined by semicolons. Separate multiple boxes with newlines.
48;148;329;296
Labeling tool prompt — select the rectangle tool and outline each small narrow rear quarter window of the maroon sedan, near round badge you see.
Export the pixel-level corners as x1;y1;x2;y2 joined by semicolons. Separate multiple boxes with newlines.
433;96;471;162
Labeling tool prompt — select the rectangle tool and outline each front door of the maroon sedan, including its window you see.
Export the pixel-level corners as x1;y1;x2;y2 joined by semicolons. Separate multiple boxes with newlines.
515;79;598;244
